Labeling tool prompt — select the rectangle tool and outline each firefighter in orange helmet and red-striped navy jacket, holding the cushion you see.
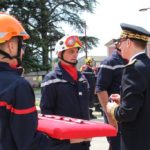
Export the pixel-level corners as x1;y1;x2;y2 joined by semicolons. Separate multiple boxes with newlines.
0;13;67;150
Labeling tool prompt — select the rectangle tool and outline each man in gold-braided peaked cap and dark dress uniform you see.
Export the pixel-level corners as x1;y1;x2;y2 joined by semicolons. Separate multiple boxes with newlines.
107;23;150;150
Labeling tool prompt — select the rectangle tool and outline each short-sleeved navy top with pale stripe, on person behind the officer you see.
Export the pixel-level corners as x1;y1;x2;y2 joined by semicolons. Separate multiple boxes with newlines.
96;51;127;95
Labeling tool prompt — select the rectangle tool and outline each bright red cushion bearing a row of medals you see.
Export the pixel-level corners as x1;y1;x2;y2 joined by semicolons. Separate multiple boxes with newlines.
37;115;117;140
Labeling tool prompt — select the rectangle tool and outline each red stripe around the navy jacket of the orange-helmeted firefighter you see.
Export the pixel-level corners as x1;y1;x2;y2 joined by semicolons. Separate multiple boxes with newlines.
0;101;36;115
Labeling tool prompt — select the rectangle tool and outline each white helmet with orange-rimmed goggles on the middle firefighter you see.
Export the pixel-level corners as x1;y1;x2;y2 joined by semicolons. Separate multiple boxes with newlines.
55;35;82;54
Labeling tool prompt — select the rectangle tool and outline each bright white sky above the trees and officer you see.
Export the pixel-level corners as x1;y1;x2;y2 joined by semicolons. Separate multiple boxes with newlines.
60;0;150;56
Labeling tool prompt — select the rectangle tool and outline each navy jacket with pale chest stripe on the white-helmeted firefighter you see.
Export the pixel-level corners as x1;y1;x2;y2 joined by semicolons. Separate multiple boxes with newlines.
40;64;89;150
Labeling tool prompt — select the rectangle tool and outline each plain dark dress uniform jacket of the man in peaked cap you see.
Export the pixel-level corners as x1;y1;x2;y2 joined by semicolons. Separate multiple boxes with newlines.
115;54;150;150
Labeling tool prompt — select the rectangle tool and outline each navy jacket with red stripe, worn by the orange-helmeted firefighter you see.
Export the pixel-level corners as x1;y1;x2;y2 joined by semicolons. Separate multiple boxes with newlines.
0;62;69;150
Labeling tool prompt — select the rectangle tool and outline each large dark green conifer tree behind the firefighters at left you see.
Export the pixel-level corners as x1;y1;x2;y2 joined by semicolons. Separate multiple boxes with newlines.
0;0;98;72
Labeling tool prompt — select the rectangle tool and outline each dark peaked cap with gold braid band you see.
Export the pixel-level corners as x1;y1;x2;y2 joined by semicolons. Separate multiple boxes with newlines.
120;23;150;42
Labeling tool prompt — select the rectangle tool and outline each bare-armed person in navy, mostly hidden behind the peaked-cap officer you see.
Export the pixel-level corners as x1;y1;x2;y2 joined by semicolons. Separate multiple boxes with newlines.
96;39;127;150
